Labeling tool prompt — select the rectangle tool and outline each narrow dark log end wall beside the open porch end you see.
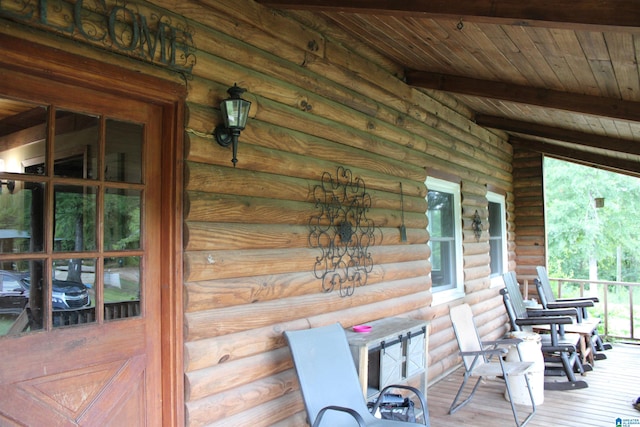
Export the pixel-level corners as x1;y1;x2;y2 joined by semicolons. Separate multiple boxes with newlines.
513;147;546;296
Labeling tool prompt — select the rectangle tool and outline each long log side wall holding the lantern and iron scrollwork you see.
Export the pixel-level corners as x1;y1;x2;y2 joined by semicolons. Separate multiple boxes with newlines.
3;0;516;426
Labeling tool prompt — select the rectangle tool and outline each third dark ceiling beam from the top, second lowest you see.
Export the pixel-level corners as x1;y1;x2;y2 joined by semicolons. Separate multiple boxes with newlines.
475;114;640;155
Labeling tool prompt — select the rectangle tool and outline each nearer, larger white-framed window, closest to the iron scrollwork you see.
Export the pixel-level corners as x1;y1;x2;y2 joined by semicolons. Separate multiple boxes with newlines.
425;177;464;305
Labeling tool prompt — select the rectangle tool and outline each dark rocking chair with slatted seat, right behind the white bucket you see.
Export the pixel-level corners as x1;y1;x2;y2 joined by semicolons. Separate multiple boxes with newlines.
500;272;592;390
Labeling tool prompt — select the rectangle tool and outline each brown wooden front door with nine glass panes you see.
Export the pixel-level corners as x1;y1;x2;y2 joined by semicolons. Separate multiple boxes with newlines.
0;69;162;426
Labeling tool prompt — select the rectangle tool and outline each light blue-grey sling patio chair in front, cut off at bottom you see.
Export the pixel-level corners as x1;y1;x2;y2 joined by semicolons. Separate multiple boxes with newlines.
284;323;430;427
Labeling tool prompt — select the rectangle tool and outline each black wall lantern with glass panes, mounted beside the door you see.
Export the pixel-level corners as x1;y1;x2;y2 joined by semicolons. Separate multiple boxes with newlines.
214;83;251;168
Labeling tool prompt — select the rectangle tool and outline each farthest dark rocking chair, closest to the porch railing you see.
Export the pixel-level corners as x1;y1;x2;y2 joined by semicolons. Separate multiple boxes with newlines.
535;266;611;360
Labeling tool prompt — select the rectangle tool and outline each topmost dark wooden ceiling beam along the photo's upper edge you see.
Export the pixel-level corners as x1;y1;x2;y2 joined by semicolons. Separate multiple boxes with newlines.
257;0;640;31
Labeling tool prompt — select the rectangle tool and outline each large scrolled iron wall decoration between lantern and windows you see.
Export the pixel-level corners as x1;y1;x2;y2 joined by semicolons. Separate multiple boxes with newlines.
309;166;375;297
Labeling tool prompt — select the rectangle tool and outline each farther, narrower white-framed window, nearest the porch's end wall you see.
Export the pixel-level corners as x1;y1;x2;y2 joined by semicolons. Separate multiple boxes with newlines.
487;192;509;282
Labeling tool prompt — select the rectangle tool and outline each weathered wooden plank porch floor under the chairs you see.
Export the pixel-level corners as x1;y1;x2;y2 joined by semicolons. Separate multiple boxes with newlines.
427;344;640;427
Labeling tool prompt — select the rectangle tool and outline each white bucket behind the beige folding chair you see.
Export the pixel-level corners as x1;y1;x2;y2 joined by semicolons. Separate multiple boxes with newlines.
504;331;544;406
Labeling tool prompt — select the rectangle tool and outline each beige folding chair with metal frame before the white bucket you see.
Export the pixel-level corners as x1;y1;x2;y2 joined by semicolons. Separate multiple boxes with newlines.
449;304;536;426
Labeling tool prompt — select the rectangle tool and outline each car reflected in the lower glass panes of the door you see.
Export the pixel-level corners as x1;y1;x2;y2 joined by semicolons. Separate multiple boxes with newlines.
0;270;91;313
